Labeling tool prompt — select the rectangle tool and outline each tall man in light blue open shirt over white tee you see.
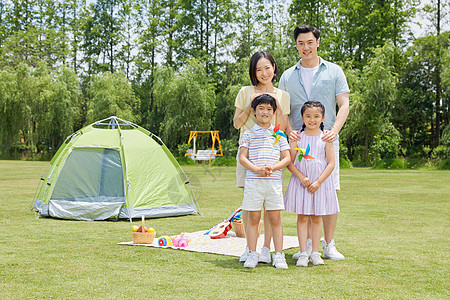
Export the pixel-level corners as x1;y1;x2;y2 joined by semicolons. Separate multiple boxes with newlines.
279;25;350;260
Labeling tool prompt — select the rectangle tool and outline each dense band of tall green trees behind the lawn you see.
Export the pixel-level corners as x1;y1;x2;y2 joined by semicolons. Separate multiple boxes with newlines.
0;0;450;165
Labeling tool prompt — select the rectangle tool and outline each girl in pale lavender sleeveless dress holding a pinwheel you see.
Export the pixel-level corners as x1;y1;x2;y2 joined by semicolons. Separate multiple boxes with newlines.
284;101;339;267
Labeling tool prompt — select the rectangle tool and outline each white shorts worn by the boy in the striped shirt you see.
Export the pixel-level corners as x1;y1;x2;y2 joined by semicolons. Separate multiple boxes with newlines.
242;179;284;211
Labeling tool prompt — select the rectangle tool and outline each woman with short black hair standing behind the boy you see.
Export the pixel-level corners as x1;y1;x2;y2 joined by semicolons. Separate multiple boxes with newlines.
233;51;292;263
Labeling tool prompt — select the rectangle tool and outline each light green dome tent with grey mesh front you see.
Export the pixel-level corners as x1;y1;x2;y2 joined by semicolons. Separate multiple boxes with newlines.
32;116;199;220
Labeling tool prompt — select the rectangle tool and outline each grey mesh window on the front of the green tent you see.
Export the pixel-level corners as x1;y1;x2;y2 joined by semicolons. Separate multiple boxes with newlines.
51;148;125;202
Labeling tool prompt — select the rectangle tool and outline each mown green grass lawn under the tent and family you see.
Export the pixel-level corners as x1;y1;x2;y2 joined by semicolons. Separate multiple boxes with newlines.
0;161;450;299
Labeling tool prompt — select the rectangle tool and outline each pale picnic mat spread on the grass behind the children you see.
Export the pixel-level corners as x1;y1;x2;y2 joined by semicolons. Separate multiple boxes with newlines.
119;230;298;257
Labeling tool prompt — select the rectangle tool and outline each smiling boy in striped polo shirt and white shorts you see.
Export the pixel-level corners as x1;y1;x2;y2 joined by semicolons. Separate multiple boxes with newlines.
239;94;290;269
